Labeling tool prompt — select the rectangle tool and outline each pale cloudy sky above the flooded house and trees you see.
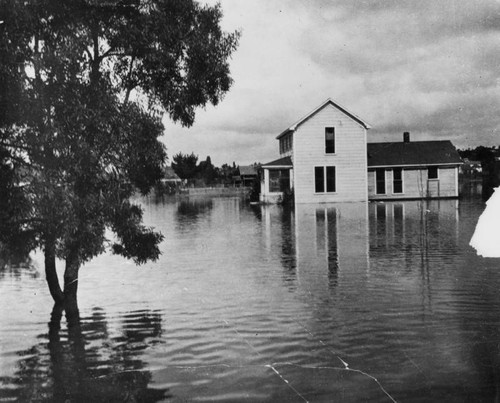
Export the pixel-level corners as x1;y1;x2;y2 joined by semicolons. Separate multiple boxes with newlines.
163;0;500;166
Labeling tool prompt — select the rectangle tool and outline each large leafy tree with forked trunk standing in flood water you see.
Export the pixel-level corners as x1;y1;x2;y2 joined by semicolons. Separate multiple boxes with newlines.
0;0;239;302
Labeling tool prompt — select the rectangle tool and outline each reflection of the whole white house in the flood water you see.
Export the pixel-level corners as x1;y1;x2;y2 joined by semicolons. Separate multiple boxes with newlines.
261;200;459;292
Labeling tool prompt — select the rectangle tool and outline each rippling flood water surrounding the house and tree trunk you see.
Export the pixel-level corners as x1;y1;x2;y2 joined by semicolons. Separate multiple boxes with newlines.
0;198;500;402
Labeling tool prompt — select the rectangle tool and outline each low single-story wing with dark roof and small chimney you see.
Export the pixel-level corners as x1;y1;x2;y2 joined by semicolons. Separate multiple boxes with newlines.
368;132;462;200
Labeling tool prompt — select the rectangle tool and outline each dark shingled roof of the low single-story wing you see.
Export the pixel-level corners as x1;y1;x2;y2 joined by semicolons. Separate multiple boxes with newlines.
367;140;462;168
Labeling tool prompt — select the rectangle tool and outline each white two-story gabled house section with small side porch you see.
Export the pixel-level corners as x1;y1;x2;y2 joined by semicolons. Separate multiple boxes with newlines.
260;99;370;203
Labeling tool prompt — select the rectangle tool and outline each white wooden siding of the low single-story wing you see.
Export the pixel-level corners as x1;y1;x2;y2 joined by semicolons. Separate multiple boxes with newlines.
368;167;458;199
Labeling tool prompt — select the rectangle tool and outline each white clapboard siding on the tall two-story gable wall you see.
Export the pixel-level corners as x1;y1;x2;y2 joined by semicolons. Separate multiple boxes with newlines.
292;105;368;203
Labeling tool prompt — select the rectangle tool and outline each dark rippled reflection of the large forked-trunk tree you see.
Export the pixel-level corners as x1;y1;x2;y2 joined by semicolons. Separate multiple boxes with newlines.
0;303;169;402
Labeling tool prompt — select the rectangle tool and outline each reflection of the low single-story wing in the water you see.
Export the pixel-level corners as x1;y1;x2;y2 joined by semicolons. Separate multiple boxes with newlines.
369;200;459;313
